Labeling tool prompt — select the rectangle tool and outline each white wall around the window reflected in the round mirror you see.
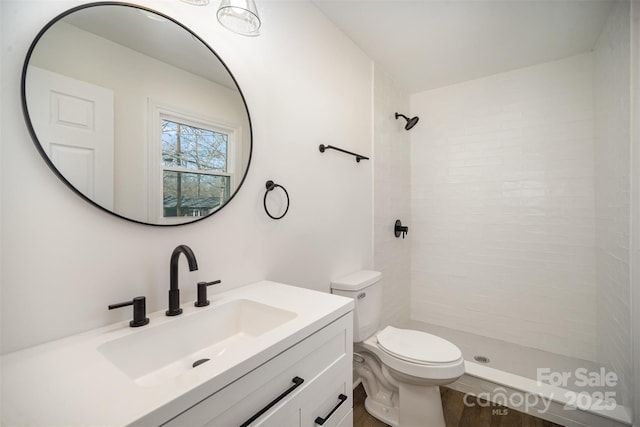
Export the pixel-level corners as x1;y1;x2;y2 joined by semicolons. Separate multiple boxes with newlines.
29;22;250;222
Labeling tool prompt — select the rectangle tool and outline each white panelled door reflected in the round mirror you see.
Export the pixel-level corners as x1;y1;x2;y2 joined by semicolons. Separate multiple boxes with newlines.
25;66;114;210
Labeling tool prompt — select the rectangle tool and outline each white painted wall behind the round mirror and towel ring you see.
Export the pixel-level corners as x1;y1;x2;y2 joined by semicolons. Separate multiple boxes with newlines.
0;0;373;353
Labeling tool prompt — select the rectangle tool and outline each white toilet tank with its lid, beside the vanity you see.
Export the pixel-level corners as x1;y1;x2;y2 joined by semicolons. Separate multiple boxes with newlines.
331;270;382;342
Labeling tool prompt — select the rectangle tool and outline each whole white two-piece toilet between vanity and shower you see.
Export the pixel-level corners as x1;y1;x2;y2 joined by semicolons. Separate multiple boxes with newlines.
331;270;464;427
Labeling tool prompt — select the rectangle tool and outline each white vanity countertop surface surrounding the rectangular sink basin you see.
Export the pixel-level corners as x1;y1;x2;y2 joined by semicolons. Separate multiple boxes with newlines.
0;281;353;427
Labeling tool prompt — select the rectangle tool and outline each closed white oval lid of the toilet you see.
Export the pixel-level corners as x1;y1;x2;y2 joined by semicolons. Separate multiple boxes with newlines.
377;326;462;365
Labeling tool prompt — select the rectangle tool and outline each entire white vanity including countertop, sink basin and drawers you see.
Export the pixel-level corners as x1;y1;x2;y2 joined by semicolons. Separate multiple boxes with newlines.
0;280;354;427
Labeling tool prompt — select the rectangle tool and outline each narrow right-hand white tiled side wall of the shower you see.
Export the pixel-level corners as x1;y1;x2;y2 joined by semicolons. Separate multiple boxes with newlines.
594;1;632;410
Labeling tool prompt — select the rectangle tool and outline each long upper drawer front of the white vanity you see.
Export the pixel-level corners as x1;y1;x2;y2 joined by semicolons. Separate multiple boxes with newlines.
164;313;353;427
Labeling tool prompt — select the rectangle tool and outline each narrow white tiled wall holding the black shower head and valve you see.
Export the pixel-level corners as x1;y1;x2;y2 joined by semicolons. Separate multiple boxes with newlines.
373;66;413;325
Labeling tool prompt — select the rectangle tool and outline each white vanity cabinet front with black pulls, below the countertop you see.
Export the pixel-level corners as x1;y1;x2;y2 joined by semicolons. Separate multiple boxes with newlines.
163;312;353;427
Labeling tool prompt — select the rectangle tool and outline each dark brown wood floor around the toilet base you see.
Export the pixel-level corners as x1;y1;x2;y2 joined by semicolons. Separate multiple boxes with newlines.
353;384;562;427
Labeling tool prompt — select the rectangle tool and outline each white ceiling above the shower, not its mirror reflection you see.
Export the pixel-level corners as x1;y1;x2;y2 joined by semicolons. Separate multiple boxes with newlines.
312;0;613;93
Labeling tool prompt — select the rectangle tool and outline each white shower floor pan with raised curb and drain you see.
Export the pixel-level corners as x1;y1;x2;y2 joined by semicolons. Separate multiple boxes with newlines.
402;321;631;427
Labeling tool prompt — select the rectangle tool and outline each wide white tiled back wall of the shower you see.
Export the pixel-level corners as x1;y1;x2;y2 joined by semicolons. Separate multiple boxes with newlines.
411;54;596;359
